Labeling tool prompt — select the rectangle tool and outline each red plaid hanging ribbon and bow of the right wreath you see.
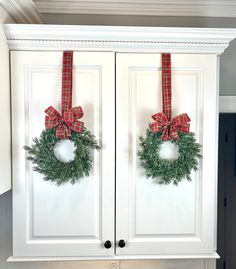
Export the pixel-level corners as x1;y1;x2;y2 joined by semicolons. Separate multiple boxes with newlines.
150;53;190;141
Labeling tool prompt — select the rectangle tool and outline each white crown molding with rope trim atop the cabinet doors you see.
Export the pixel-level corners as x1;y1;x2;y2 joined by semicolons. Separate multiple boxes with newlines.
4;24;236;54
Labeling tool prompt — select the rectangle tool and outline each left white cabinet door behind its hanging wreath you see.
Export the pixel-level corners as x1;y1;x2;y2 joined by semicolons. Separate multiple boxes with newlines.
11;51;115;257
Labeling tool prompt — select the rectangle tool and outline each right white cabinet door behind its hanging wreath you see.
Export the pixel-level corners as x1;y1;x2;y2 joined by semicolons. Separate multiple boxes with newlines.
116;54;218;255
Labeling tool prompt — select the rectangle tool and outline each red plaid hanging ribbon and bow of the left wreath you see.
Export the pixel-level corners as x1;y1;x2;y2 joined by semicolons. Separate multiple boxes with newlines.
45;51;84;139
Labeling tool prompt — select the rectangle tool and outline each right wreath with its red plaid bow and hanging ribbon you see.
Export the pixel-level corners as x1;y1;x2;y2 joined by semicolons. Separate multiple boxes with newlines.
138;54;202;185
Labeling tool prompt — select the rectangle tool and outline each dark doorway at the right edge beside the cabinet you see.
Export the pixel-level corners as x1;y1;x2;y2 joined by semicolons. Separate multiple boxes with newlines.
217;114;236;269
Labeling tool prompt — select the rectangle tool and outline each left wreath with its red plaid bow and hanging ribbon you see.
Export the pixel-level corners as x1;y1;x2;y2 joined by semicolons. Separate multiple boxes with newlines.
24;51;100;185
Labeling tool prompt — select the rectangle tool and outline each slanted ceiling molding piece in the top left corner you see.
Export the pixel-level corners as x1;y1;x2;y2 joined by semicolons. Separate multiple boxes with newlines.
0;0;44;24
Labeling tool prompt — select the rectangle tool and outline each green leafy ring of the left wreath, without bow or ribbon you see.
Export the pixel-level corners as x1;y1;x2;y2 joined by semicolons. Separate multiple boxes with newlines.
24;128;100;185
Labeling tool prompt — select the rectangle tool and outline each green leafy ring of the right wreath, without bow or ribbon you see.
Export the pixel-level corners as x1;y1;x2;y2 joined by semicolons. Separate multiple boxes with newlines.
138;129;202;185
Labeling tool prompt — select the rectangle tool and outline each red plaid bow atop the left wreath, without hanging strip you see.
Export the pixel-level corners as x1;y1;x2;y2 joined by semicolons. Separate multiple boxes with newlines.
45;106;84;139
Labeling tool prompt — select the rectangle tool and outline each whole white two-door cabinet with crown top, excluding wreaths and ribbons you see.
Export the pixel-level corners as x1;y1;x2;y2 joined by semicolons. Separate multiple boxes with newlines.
6;26;235;260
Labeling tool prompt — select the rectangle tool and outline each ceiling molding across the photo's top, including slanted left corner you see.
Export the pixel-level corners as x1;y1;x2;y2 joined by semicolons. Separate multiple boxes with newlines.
0;0;236;24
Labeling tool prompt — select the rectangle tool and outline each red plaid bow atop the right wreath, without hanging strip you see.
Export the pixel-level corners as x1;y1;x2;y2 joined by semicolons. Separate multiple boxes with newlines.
151;113;190;141
